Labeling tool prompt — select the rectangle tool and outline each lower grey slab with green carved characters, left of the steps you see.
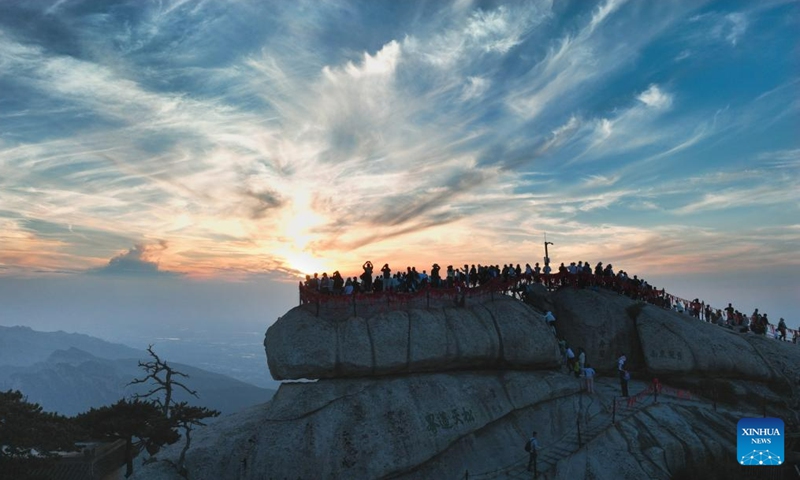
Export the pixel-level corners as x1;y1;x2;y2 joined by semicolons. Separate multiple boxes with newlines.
135;371;578;480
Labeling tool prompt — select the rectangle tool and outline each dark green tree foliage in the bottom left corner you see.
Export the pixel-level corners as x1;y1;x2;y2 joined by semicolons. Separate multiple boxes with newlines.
0;390;78;480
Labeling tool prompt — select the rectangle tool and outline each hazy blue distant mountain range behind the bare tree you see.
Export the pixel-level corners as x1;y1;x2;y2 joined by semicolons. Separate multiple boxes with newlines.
0;326;275;416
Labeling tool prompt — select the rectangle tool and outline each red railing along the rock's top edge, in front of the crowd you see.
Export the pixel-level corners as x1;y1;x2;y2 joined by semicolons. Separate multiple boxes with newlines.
299;272;800;340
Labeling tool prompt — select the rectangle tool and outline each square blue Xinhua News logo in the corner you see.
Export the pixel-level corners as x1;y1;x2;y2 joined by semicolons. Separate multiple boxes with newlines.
736;418;784;467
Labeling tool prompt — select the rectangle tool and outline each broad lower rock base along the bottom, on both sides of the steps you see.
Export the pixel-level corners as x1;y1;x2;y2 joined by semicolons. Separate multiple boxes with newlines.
134;371;756;480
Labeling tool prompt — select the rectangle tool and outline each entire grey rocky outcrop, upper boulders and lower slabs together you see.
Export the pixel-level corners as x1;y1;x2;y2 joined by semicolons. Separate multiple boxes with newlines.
136;290;800;480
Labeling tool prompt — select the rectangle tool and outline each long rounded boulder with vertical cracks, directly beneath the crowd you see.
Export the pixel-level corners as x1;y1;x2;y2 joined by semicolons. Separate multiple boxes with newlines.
264;296;559;380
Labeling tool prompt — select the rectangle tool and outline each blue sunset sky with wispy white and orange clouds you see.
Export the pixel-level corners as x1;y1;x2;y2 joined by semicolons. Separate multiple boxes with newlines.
0;0;800;336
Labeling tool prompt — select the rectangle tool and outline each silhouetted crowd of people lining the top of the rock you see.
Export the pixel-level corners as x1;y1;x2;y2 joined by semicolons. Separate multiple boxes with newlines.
301;261;798;343
